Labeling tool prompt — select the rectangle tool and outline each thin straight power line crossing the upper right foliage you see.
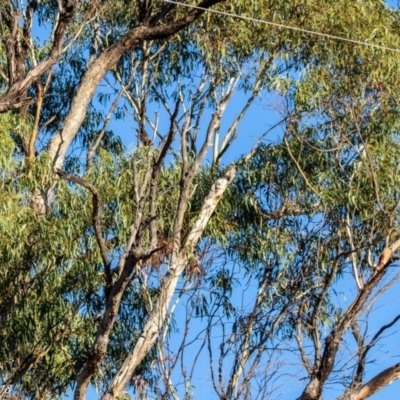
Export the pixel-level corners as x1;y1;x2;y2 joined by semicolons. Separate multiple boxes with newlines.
162;0;400;53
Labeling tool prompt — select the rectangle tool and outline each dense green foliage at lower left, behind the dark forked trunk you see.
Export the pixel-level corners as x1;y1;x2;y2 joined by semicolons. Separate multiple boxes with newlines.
0;140;195;398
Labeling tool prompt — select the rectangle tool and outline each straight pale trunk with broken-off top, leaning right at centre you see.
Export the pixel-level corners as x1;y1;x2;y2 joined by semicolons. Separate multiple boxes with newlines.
102;167;235;400
